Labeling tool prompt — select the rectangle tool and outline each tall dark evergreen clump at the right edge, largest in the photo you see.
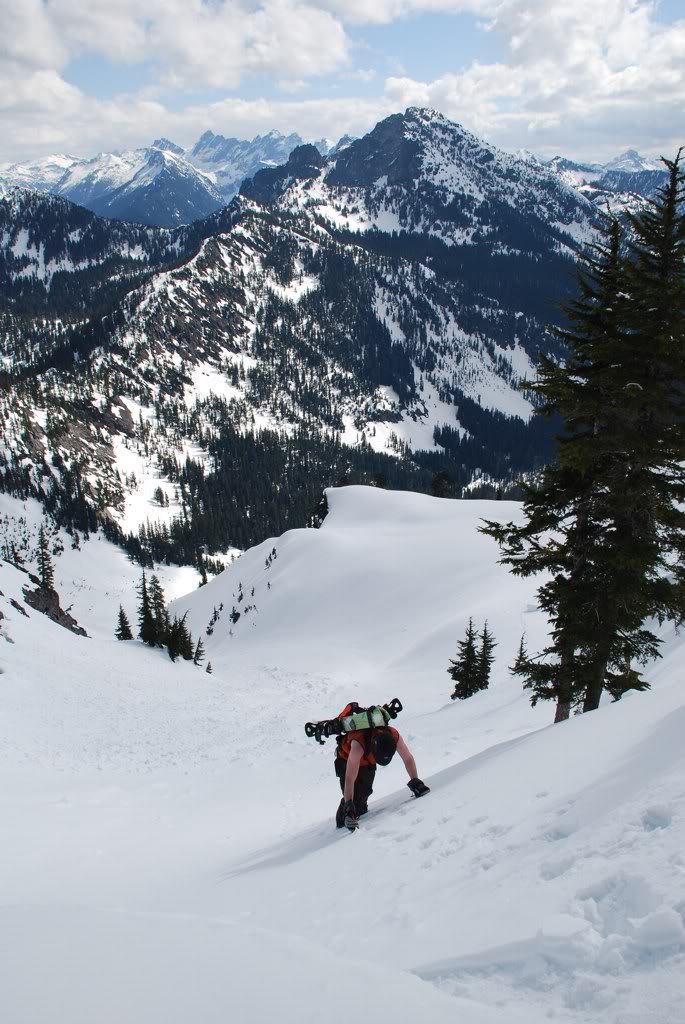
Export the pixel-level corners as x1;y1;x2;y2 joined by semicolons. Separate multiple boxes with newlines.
484;159;685;721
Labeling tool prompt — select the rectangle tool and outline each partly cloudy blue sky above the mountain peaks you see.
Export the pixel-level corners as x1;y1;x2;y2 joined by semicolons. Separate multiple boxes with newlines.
0;0;685;163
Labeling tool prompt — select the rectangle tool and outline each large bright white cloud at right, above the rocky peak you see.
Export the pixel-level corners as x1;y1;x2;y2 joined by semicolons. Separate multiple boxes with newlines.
386;0;685;158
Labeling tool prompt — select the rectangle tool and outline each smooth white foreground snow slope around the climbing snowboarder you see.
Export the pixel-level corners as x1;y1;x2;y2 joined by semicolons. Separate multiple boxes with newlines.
0;487;685;1024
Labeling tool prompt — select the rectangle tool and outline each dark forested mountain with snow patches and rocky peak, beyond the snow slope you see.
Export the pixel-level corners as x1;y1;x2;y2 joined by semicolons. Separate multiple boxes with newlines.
0;109;600;567
